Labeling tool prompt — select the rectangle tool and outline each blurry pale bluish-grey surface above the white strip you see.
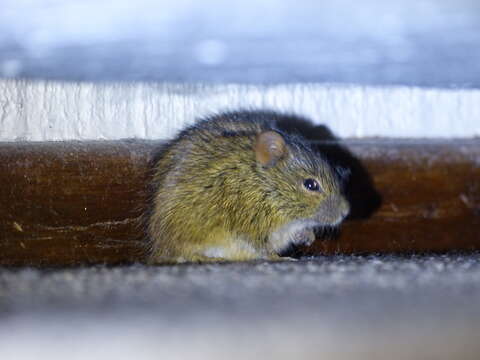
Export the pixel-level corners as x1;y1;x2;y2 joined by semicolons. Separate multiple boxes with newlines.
0;0;480;88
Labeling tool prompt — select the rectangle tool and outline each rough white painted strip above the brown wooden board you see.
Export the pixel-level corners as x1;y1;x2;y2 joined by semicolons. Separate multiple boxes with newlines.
0;79;480;141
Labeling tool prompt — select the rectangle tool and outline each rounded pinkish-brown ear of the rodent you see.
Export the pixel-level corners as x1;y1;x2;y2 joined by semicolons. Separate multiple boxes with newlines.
255;131;287;166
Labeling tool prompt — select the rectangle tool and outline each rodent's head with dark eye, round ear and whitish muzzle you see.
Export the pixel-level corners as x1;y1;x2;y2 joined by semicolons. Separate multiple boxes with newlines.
255;130;350;226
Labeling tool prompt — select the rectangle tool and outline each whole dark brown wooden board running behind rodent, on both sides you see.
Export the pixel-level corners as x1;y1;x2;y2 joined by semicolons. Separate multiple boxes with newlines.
0;140;480;266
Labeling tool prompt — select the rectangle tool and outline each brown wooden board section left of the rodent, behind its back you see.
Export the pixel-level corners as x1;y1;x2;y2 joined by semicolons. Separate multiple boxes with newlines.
0;142;152;265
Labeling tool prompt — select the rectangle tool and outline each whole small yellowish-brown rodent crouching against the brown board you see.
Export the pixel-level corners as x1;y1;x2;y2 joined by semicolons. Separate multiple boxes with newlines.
148;112;349;263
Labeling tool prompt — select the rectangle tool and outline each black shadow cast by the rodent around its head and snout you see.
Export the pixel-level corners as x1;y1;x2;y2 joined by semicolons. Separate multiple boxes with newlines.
270;112;382;257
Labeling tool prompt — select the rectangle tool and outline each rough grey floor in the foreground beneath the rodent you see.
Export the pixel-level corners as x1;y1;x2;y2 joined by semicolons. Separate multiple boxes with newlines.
0;254;480;359
